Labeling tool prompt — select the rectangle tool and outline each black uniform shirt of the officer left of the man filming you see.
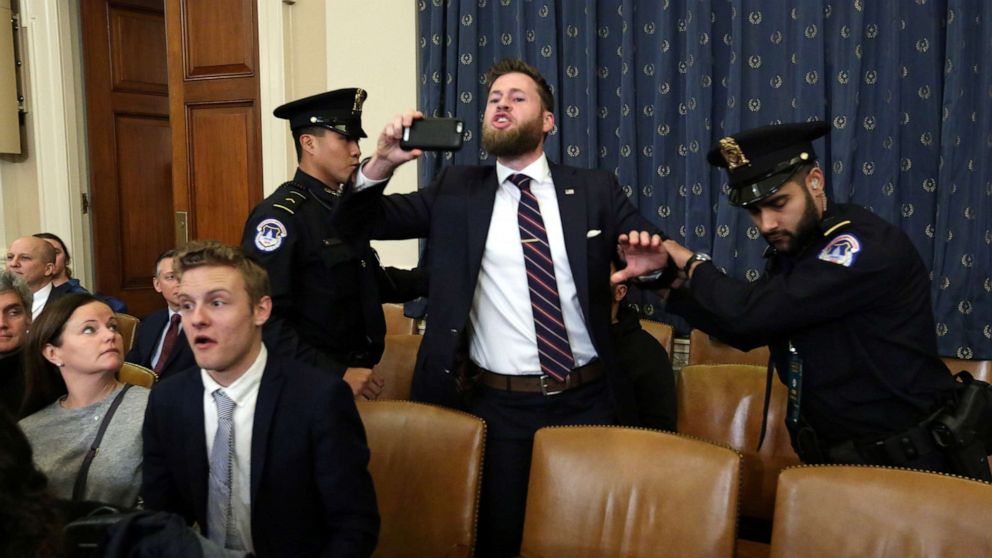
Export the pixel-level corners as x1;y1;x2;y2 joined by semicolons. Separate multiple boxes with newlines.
241;170;385;367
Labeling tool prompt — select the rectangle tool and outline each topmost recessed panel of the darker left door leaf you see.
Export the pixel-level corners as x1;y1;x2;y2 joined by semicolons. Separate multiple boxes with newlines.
110;7;169;95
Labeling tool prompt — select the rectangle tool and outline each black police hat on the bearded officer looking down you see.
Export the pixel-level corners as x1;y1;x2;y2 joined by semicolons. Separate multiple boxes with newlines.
706;121;830;207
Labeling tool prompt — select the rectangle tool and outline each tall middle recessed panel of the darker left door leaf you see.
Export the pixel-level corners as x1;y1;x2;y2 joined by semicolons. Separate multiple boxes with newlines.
115;115;173;290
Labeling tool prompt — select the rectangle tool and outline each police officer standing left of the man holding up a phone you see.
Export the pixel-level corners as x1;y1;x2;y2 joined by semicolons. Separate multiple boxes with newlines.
241;88;420;399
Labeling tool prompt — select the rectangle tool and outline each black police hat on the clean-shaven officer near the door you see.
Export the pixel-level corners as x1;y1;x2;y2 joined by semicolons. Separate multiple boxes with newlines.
272;87;368;139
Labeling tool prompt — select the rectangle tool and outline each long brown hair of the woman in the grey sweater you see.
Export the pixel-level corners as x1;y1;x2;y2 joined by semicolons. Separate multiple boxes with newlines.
21;293;105;417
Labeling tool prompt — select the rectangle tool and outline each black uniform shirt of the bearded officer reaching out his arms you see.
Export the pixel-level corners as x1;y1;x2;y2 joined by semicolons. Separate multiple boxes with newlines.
668;204;953;442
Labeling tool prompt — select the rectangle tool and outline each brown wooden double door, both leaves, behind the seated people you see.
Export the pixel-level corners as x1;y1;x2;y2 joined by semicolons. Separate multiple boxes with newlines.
80;0;262;316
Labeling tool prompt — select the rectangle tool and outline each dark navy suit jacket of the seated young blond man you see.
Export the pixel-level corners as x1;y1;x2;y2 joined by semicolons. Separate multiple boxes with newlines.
142;351;379;558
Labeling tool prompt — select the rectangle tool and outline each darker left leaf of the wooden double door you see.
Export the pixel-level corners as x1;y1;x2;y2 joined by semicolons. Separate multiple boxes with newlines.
80;0;175;316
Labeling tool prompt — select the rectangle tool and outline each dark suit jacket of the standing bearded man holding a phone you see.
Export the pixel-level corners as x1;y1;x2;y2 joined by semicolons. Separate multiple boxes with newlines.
334;164;657;423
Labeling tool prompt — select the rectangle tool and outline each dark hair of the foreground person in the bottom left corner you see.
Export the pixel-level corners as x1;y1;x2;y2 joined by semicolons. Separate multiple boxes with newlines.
0;409;62;557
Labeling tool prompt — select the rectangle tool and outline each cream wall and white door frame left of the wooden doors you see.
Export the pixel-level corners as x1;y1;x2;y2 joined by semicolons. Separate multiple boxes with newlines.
0;0;92;285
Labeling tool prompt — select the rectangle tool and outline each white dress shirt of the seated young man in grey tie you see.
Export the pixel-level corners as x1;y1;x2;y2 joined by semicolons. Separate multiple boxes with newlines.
200;344;268;552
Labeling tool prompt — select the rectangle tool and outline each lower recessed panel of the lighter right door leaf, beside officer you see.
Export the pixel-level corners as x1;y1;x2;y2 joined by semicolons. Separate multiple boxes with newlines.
188;103;254;244
